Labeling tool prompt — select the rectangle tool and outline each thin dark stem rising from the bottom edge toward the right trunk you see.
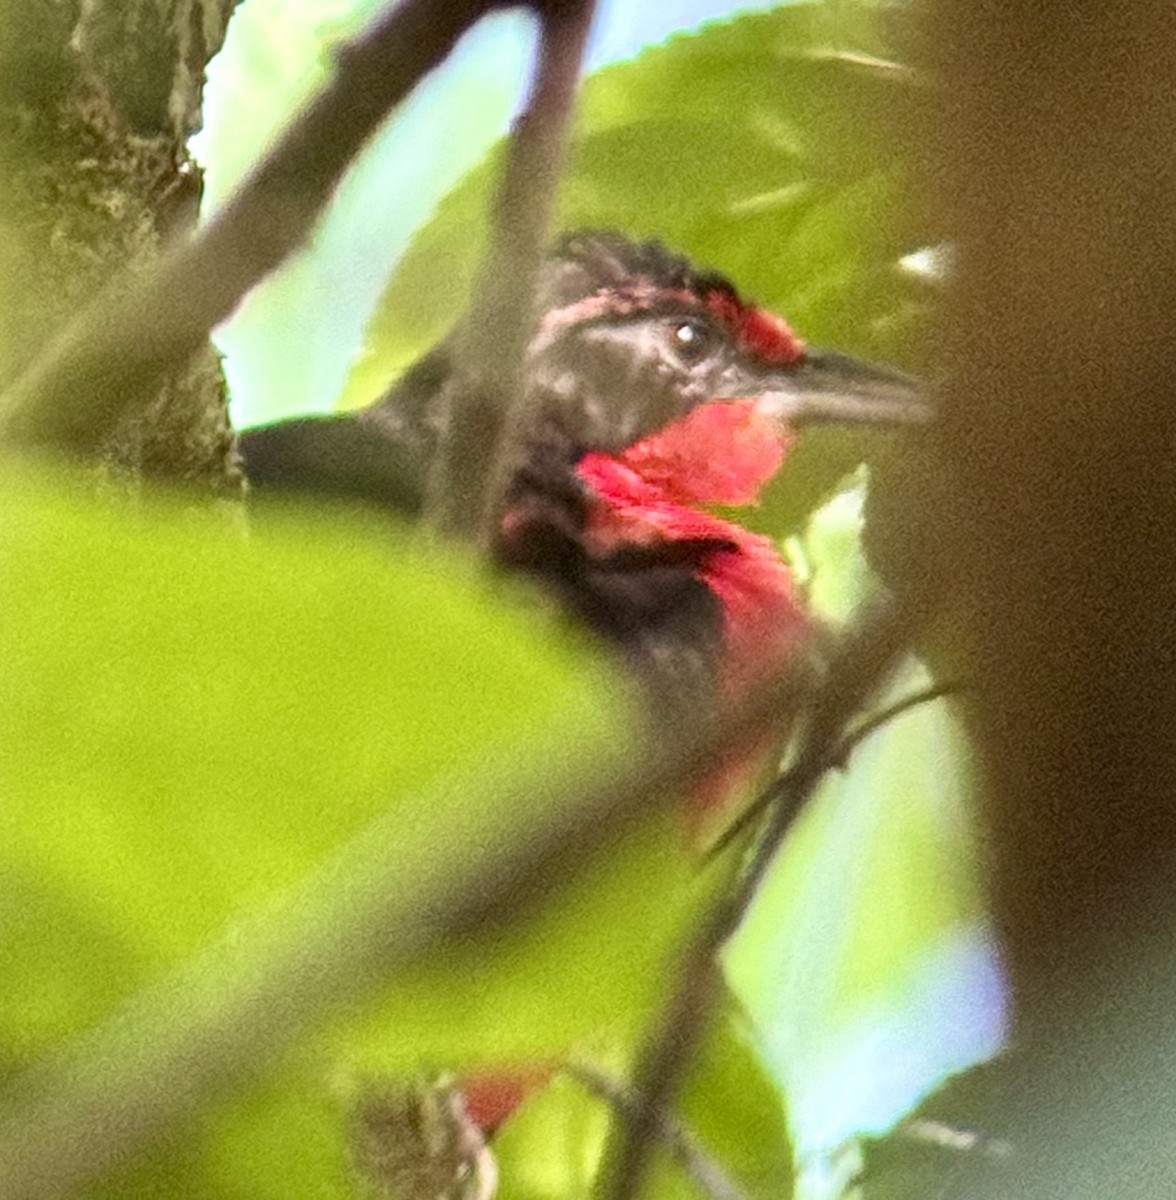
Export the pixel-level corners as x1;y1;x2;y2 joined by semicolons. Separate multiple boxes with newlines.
599;596;930;1200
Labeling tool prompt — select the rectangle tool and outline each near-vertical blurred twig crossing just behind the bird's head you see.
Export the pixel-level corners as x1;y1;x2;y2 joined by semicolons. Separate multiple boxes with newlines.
427;0;595;548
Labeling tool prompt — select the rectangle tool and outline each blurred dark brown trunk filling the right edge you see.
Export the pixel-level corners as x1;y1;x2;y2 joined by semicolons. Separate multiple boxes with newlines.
930;0;1176;1198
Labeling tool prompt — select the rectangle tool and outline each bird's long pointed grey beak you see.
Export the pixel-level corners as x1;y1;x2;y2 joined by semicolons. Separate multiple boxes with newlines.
755;349;934;427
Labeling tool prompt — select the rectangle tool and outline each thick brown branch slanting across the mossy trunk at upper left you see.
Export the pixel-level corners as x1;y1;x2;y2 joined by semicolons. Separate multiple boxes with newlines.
0;0;502;455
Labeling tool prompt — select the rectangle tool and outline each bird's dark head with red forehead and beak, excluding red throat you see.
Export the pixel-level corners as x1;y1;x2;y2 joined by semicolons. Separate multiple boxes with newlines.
527;230;926;463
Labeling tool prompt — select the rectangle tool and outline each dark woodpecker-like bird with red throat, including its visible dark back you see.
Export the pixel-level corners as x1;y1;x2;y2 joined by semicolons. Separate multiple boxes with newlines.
239;229;928;753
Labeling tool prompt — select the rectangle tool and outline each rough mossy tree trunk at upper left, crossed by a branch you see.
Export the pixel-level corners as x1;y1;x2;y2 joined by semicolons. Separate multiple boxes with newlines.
0;0;240;492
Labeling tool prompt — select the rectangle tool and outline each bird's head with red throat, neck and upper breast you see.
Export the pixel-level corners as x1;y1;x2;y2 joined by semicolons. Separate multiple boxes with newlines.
487;232;926;696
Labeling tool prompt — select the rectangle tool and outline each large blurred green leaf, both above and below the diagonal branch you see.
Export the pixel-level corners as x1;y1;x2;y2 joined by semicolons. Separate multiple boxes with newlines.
0;476;692;1198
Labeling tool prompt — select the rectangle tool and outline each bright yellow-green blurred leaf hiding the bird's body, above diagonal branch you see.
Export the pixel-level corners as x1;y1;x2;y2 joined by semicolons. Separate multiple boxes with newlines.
0;468;618;993
